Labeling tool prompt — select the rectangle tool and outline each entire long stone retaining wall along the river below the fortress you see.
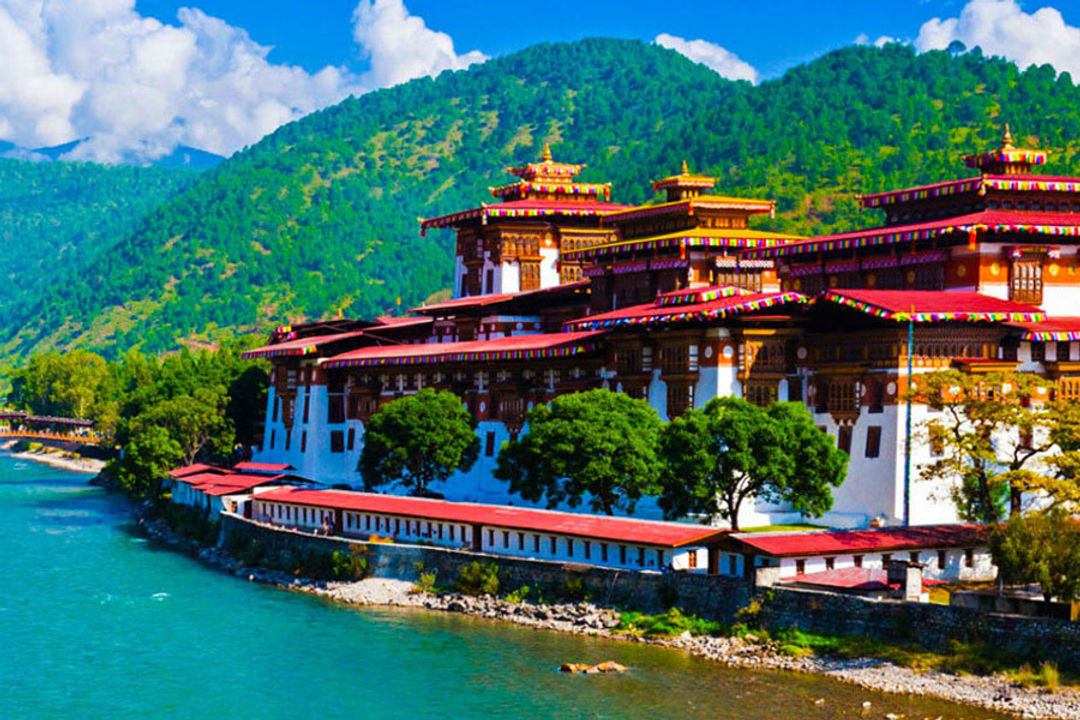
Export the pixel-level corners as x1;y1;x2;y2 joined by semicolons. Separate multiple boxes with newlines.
221;515;1080;668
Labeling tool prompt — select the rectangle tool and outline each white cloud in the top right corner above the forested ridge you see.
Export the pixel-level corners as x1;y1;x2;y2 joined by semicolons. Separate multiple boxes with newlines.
915;0;1080;74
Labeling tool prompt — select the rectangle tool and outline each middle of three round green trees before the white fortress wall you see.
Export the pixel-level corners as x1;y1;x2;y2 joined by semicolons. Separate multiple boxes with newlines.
495;390;660;515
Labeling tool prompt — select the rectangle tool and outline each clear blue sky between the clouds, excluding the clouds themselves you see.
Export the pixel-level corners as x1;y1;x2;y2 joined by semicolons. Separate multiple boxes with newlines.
136;0;1002;78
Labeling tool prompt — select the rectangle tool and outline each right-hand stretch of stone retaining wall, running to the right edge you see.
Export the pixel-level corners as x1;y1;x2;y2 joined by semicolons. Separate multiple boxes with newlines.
760;587;1080;667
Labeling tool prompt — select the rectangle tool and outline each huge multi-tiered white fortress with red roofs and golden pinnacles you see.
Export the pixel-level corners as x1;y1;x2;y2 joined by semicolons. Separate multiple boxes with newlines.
236;133;1080;527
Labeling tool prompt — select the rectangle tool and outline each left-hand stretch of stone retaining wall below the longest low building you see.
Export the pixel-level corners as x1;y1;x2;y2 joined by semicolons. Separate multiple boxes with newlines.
221;515;752;620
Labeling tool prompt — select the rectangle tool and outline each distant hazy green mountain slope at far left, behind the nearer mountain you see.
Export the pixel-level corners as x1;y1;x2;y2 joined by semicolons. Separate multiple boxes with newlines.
0;159;198;319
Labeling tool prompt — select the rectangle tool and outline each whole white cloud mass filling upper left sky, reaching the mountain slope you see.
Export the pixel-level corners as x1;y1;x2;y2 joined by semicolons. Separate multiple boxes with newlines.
0;0;486;162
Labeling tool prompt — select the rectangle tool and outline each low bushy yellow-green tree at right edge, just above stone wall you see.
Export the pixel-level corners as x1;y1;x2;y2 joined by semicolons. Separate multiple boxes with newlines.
990;508;1080;602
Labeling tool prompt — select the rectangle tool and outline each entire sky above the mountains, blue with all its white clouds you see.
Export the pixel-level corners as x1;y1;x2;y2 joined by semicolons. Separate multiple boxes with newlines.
0;0;1080;162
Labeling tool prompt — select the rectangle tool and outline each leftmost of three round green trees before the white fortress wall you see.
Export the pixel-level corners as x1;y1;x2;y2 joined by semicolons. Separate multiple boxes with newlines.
357;388;480;494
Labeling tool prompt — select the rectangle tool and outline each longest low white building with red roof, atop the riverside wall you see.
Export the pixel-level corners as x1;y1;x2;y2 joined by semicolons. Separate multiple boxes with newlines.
251;488;727;572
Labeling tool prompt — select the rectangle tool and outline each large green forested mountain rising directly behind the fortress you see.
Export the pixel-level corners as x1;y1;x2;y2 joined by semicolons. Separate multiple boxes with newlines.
6;40;1080;354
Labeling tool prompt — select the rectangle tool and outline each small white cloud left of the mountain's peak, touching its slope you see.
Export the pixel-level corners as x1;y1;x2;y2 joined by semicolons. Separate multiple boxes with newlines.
352;0;487;87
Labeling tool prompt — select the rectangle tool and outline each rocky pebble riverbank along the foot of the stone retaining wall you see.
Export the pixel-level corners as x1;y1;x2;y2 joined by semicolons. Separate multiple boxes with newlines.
139;509;1080;720
